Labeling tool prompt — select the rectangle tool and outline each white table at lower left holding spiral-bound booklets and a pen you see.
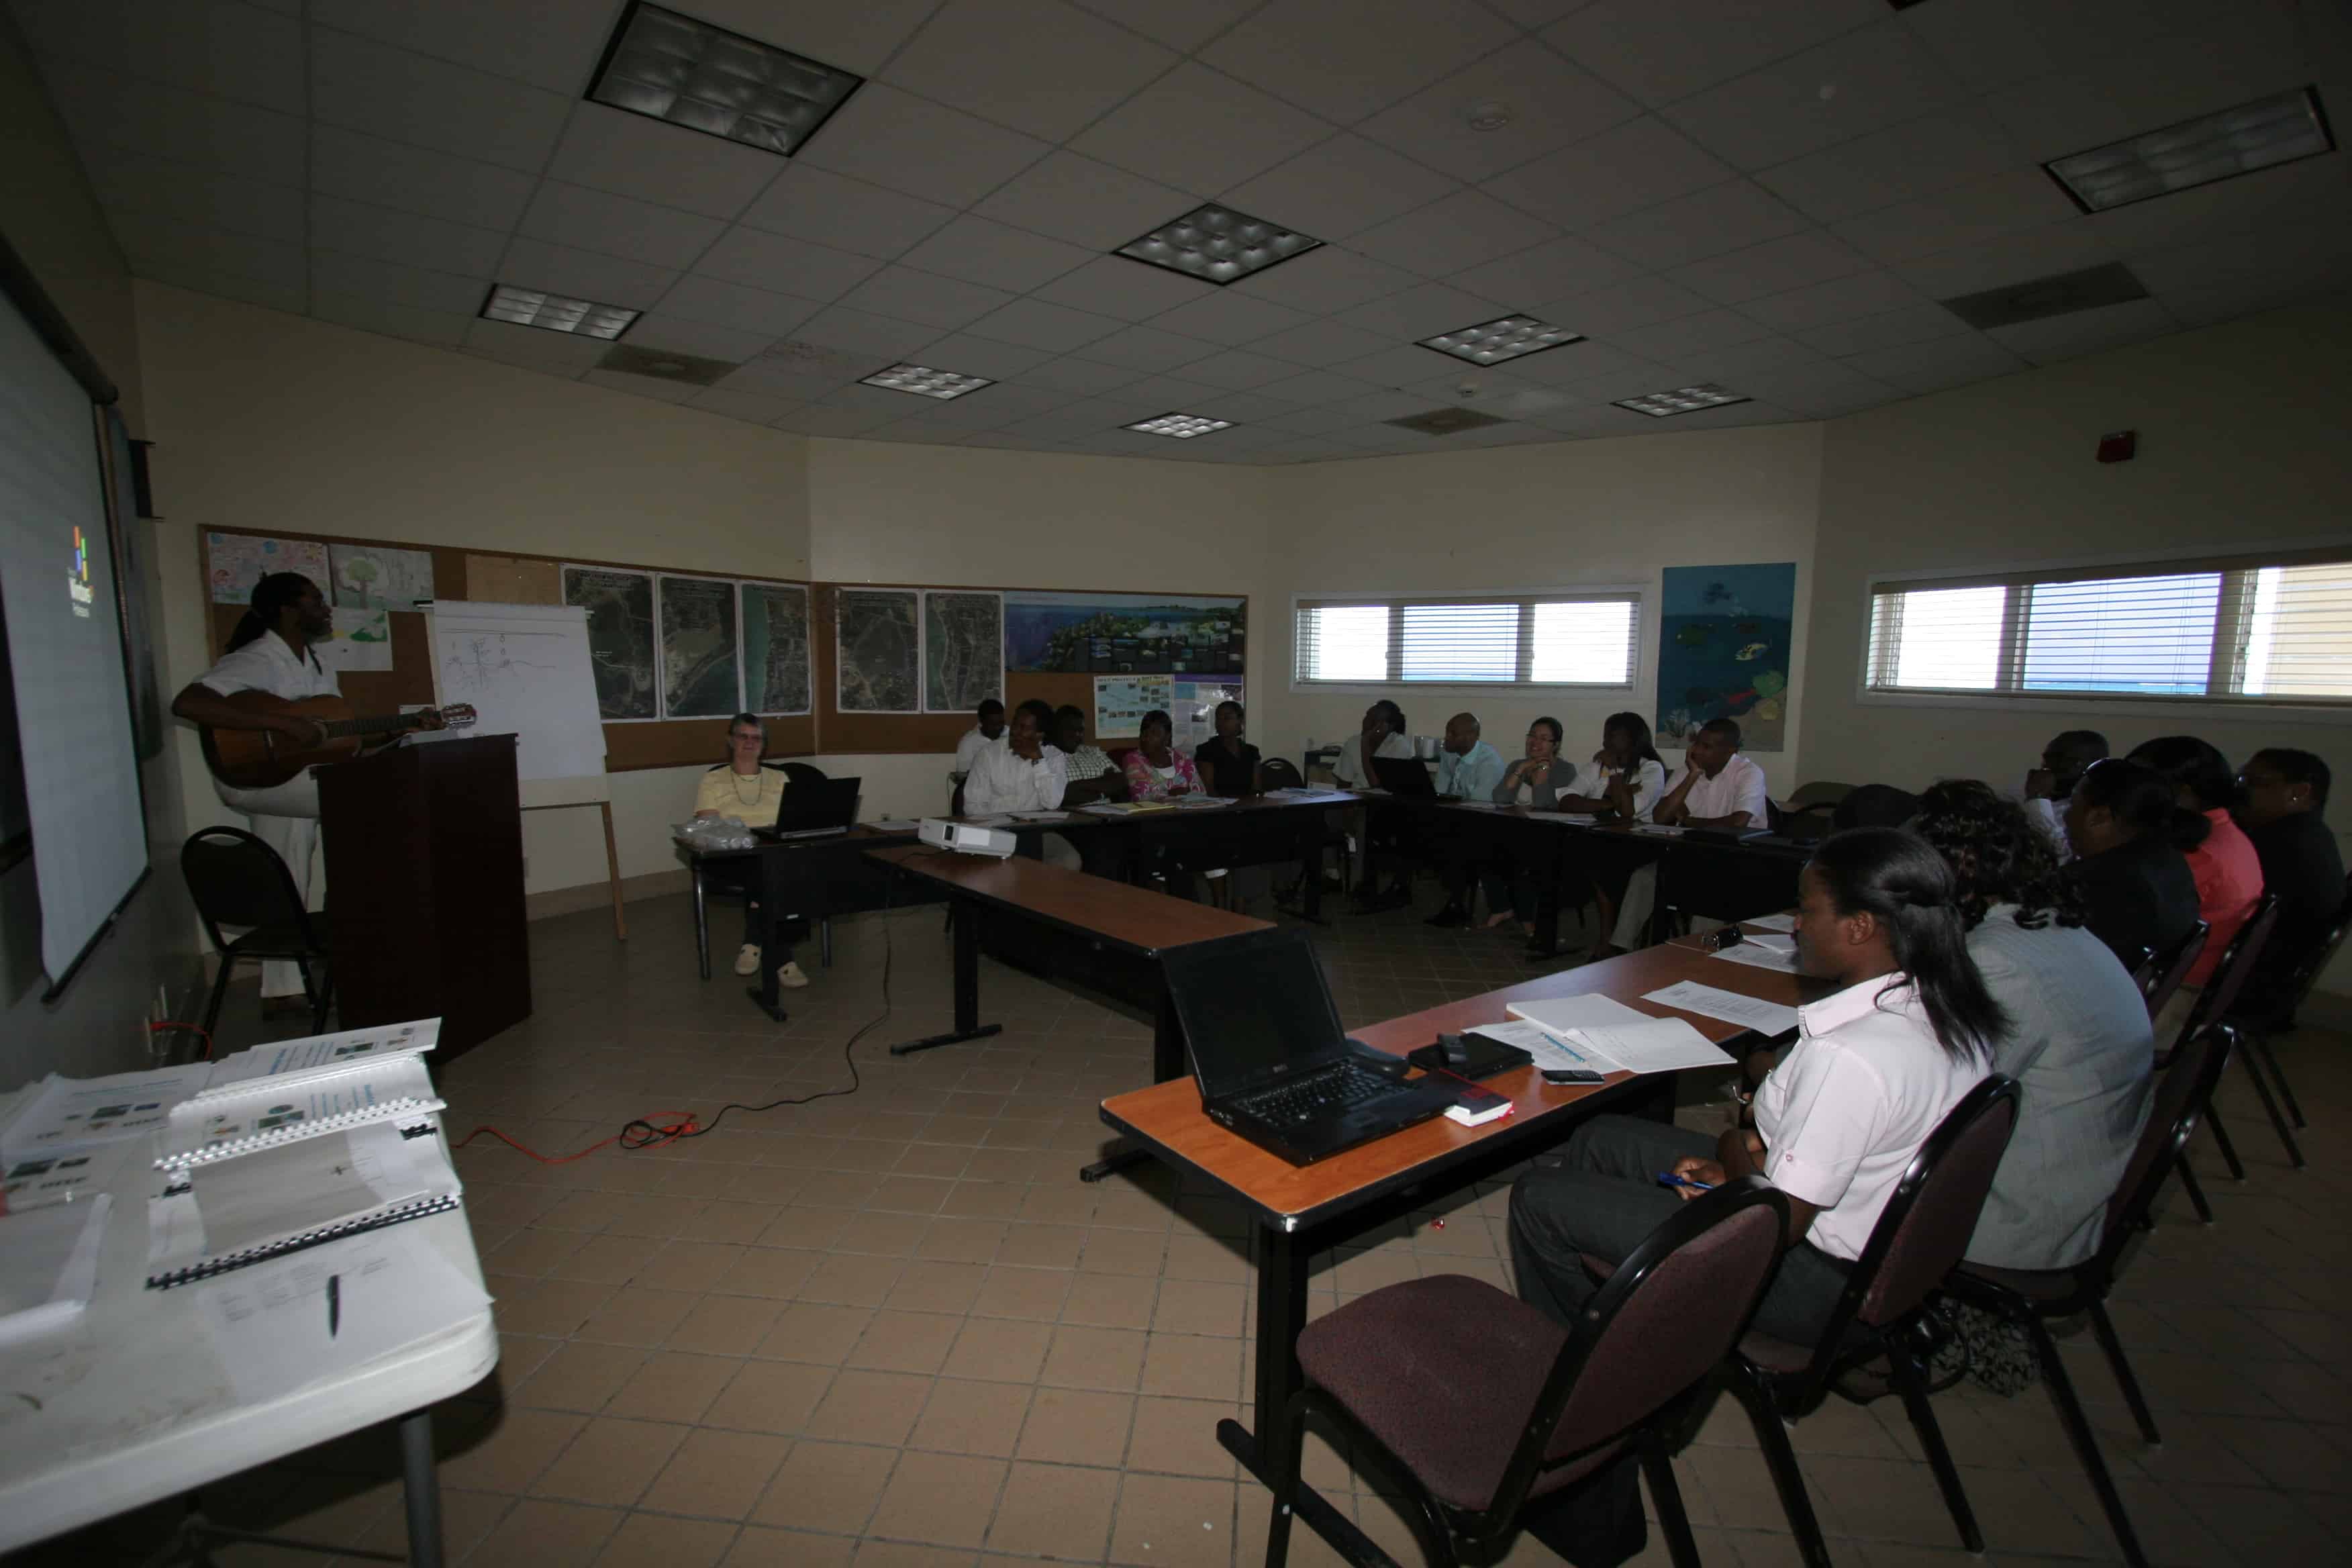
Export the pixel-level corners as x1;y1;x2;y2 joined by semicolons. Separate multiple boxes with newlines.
0;1095;499;1568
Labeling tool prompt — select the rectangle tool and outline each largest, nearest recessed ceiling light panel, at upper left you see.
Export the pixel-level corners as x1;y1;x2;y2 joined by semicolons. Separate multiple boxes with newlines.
588;0;865;158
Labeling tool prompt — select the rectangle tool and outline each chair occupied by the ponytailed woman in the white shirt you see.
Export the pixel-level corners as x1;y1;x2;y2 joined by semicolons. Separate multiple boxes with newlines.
1731;1075;2018;1568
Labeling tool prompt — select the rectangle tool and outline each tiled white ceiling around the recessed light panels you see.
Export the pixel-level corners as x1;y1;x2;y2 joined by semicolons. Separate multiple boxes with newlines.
9;0;2352;463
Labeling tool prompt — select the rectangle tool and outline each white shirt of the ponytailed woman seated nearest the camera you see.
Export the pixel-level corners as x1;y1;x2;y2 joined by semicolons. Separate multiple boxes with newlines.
1769;968;1988;1258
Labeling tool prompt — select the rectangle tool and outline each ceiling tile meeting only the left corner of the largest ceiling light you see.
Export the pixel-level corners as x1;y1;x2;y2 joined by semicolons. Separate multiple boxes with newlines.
311;28;571;174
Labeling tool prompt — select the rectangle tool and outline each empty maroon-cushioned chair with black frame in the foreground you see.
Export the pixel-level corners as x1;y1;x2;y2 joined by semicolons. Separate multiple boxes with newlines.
1265;1178;1787;1568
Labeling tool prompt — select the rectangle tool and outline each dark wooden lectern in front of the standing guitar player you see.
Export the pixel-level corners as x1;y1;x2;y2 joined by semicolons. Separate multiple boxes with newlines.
317;736;532;1063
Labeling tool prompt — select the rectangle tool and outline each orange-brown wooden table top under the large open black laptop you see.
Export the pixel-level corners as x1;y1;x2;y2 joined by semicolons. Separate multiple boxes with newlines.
1100;926;1828;1230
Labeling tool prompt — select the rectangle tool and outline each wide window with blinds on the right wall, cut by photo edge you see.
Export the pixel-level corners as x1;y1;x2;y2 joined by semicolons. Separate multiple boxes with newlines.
1865;550;2352;705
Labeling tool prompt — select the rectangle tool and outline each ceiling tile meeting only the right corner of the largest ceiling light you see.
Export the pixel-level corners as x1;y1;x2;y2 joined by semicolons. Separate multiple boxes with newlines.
882;0;1179;141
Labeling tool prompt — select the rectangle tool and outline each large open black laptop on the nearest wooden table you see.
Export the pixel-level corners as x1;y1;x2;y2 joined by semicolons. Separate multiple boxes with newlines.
1159;928;1461;1166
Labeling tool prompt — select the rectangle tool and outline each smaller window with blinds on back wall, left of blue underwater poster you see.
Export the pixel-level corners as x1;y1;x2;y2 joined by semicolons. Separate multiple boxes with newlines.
1293;590;1642;689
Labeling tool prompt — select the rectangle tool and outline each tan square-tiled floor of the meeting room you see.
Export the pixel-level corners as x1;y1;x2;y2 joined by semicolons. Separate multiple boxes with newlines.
23;898;2352;1568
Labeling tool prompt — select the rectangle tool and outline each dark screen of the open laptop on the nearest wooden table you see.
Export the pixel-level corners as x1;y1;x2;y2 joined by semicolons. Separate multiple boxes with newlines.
1159;928;1343;1100
